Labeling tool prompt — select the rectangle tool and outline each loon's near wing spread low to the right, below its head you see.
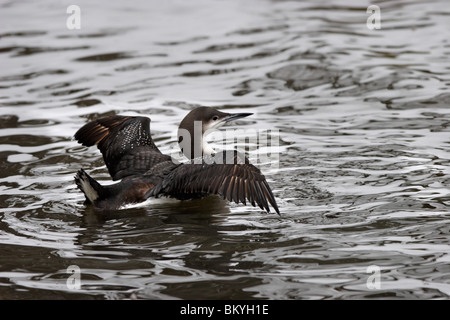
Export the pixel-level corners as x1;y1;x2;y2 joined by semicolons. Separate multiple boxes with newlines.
151;154;280;214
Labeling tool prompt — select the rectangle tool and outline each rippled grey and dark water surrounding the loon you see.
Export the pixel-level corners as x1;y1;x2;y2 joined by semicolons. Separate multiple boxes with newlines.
0;0;450;299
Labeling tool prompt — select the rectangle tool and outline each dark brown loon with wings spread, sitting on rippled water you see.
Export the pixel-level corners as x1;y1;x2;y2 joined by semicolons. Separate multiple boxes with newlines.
75;107;280;214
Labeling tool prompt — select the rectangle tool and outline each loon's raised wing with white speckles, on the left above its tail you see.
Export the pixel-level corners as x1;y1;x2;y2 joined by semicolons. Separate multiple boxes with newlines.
75;115;170;180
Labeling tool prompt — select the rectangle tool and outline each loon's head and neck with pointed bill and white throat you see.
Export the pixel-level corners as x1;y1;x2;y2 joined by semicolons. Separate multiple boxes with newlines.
178;107;253;159
